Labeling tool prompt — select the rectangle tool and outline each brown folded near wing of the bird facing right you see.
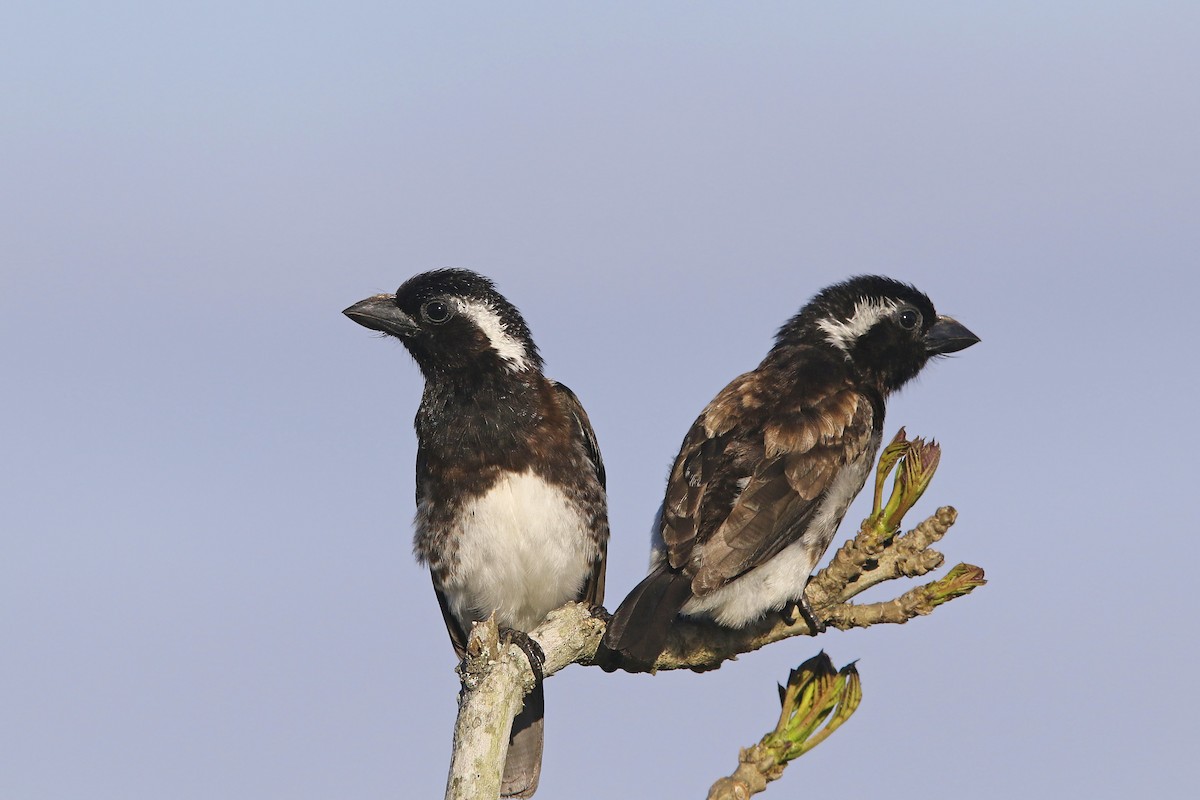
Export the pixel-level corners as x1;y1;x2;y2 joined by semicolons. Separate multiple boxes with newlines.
692;384;874;595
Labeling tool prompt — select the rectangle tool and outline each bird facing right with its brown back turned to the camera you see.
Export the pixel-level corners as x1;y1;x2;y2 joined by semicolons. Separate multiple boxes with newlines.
596;276;979;672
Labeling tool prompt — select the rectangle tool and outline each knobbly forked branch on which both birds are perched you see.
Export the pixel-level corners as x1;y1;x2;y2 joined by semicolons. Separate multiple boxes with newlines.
446;428;986;800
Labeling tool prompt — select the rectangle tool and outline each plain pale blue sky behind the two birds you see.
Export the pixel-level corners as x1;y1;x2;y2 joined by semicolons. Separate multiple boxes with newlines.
0;0;1200;800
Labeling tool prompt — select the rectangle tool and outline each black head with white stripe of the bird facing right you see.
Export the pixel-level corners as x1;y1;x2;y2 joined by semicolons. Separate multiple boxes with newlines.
775;275;979;392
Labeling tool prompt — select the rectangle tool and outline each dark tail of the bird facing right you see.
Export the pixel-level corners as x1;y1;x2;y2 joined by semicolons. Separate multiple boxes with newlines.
595;565;691;672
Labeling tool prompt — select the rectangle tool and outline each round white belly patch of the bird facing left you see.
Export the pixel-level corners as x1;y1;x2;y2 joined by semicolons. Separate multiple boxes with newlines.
443;473;595;631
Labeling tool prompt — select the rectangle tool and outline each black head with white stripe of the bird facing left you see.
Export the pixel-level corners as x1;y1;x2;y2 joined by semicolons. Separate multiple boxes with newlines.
342;269;541;378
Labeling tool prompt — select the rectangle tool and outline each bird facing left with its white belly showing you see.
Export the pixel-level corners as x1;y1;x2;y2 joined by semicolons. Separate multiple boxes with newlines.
343;269;608;798
